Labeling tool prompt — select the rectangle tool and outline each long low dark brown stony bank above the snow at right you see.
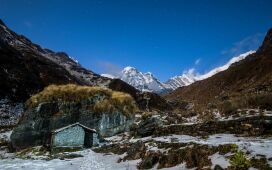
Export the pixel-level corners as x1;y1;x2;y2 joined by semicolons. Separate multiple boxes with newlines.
153;116;272;136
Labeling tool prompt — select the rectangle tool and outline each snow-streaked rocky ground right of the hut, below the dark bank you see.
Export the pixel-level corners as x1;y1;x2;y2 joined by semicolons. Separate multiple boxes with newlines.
94;134;272;169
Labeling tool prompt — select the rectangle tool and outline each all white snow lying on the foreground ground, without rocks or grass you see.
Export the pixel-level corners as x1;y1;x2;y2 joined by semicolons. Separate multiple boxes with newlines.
0;134;272;170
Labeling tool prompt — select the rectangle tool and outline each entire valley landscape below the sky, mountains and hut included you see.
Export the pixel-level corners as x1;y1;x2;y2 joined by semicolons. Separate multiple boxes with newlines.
0;15;272;170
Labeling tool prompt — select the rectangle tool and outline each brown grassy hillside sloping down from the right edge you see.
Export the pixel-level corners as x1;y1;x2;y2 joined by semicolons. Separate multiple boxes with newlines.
164;29;272;112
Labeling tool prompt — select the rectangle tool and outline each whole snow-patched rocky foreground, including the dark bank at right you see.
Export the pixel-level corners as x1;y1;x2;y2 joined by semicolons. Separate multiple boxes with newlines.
0;104;272;170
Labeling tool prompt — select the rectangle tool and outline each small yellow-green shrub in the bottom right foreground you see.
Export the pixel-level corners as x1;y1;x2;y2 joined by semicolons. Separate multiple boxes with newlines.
230;151;251;170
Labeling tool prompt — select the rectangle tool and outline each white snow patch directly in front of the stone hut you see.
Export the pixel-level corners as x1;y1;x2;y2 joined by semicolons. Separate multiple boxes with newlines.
0;149;141;170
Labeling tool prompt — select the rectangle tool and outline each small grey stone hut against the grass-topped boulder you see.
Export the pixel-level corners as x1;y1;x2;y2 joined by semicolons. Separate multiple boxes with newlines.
51;123;99;150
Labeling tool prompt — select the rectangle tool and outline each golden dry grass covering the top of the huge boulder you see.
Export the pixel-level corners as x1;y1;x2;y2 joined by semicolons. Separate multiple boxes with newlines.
26;84;138;115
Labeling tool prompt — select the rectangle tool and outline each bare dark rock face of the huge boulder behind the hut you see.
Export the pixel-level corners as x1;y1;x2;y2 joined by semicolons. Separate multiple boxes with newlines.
11;97;133;150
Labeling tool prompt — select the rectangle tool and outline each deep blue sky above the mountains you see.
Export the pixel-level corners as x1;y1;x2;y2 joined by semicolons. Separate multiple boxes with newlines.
0;0;272;80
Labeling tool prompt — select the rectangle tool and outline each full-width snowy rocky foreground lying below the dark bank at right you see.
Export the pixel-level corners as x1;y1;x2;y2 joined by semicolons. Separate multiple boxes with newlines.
0;124;272;169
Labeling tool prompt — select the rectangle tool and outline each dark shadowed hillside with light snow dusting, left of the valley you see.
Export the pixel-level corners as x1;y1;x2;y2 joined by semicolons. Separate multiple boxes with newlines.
0;21;109;101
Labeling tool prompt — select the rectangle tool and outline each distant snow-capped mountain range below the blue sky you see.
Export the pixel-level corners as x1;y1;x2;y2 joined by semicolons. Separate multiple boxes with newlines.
102;51;255;94
